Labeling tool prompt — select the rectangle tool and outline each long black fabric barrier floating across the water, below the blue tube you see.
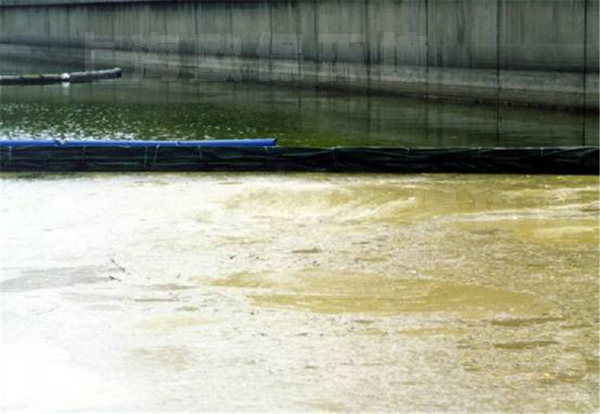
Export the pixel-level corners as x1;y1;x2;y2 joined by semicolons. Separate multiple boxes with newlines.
0;146;599;175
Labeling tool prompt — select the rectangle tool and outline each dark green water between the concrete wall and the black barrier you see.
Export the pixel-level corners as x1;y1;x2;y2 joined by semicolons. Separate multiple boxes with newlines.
0;78;598;147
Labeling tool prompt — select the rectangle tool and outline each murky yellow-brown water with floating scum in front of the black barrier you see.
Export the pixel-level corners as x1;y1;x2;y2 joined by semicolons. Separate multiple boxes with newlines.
0;174;599;412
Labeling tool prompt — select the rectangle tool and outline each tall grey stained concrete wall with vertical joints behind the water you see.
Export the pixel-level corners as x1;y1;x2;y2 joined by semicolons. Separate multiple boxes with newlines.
0;0;599;111
